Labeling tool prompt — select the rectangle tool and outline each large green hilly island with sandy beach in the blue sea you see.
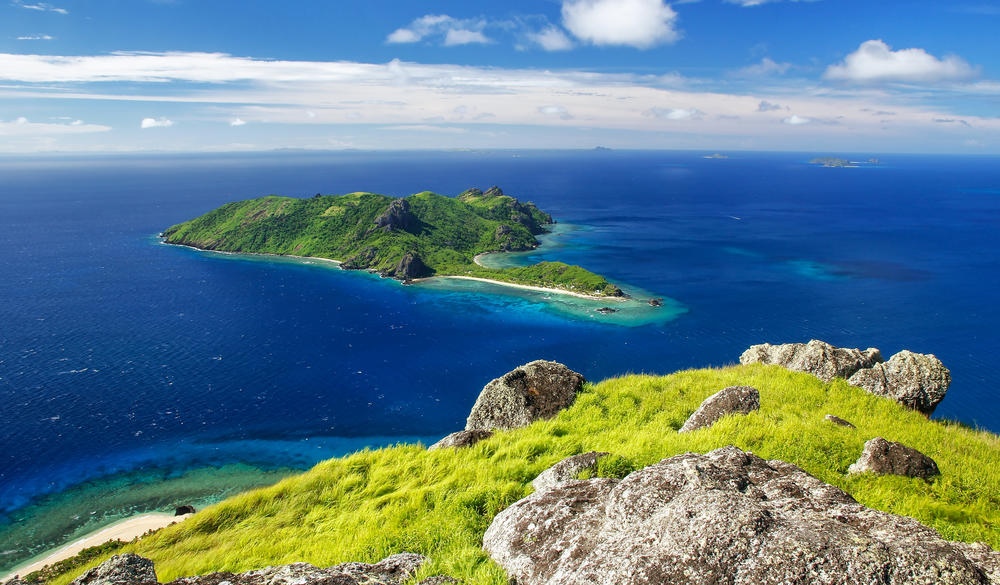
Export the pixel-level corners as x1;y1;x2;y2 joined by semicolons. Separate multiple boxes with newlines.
161;187;626;298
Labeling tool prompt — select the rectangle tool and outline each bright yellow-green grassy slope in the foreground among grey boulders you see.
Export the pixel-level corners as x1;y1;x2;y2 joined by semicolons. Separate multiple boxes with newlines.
35;365;1000;585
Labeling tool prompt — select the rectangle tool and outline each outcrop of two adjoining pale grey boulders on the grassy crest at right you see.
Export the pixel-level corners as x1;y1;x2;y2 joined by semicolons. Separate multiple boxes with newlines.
740;339;951;416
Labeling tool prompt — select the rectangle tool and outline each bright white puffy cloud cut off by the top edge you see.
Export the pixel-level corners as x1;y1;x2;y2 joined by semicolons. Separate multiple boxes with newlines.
562;0;680;49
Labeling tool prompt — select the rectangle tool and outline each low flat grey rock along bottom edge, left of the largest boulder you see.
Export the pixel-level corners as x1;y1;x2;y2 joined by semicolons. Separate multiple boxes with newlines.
161;553;427;585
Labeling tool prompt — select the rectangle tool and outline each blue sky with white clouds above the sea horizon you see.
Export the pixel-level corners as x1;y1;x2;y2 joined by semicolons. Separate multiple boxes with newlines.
0;0;1000;155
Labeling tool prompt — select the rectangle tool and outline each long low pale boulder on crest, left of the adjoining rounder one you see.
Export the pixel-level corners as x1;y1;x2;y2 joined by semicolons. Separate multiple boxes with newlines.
740;339;882;382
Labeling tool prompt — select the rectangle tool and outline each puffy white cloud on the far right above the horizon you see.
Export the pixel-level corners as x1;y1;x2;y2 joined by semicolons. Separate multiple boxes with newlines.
823;40;976;83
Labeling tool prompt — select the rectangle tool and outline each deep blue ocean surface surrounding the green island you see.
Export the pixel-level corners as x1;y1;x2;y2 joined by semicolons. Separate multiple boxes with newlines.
0;151;1000;569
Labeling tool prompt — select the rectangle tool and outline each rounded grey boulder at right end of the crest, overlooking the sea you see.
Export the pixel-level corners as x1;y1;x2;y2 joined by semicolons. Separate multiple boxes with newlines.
848;350;951;415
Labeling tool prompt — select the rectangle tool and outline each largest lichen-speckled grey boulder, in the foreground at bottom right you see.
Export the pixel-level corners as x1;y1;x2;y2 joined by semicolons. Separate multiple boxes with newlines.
483;447;1000;585
